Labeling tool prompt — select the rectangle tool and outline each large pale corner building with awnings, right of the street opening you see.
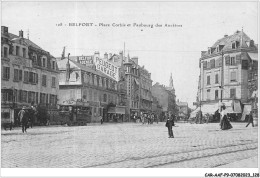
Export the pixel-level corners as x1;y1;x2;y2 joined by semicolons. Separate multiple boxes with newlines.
198;30;257;113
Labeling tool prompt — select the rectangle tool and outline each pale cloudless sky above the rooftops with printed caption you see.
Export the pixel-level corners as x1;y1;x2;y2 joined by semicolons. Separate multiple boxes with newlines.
1;1;258;108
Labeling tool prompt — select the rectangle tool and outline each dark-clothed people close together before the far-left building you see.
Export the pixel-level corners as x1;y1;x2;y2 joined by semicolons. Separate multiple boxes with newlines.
18;106;37;133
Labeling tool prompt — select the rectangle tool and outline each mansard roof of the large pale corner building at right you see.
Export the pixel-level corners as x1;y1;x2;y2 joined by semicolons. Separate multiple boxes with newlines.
203;31;256;55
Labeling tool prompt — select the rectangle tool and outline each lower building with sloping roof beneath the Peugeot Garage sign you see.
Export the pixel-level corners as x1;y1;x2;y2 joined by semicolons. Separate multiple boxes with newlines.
58;55;119;122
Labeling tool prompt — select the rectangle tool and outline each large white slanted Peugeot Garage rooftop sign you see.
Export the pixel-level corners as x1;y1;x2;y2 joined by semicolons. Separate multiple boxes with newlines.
94;57;119;81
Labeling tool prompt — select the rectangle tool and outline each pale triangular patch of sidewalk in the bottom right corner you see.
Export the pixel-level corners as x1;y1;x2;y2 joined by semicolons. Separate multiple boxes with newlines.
217;156;258;168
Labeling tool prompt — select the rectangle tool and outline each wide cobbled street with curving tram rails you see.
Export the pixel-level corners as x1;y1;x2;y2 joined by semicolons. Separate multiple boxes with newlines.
1;123;258;168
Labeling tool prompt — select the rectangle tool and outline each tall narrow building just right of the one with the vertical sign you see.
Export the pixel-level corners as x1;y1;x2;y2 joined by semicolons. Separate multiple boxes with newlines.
139;66;153;112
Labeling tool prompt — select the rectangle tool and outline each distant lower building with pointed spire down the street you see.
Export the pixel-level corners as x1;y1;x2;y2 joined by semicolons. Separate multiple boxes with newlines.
152;75;177;114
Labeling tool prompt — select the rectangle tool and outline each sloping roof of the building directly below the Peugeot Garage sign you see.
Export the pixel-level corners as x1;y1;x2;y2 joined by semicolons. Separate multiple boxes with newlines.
57;58;114;80
